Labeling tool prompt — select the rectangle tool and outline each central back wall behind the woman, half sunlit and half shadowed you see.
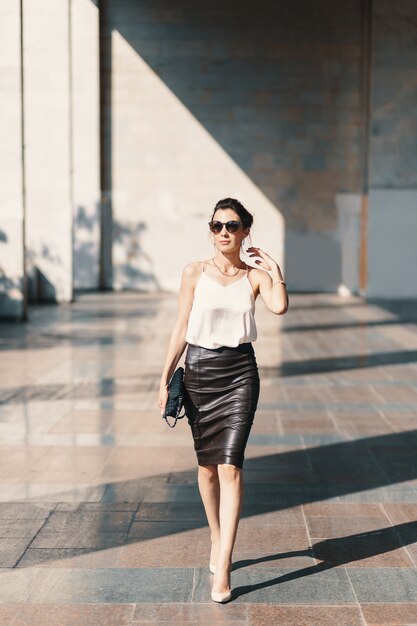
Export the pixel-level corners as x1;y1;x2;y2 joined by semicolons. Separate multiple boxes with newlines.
102;0;362;290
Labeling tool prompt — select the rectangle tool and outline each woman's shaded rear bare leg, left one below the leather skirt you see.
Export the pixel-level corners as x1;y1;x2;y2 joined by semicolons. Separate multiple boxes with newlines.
198;465;220;565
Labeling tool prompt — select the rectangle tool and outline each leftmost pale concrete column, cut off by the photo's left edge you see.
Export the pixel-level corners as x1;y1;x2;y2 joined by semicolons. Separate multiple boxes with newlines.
0;0;24;319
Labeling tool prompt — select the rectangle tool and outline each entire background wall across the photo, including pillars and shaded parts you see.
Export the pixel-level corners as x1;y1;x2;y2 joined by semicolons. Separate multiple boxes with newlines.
0;0;417;317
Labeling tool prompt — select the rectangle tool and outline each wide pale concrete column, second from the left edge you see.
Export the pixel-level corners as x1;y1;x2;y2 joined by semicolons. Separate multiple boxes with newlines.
23;0;72;302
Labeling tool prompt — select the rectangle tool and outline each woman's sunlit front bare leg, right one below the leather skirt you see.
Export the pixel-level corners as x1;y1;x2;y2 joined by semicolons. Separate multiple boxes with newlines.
213;463;243;592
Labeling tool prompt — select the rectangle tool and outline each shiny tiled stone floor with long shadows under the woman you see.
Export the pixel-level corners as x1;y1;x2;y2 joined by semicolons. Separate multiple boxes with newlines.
0;294;417;626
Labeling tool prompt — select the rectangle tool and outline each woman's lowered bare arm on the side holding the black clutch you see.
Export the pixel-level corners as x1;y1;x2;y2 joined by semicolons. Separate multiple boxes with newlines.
158;263;196;413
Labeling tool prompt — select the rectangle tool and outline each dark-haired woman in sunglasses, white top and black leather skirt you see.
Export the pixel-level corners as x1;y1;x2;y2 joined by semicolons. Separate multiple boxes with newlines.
158;198;288;602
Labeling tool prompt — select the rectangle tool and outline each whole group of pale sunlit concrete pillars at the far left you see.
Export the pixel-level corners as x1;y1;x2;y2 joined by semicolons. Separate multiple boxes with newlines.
0;0;100;318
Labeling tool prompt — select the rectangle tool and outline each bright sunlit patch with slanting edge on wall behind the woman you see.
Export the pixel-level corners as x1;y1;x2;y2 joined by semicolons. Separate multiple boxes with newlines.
108;31;284;290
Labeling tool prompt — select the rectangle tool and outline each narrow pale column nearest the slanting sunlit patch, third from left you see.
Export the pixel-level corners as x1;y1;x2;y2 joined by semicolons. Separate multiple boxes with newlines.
71;0;100;289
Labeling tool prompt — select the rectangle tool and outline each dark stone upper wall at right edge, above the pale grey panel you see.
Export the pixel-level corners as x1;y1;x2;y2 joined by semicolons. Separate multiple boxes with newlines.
370;0;417;189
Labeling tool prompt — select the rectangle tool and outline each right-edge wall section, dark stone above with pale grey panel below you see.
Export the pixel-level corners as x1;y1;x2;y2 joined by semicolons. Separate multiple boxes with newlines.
367;0;417;297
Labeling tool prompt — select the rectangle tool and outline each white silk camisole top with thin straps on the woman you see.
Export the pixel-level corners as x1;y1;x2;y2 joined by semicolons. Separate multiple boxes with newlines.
185;261;257;349
